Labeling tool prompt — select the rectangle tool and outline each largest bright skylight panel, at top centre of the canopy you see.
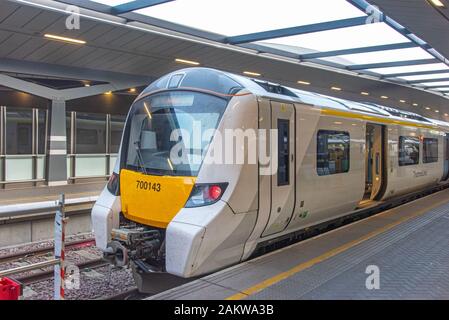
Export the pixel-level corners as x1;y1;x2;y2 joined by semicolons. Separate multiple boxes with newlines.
135;0;366;36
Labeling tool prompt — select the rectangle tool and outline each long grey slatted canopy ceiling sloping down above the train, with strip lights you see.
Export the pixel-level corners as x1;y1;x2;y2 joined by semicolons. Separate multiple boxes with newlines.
0;1;449;119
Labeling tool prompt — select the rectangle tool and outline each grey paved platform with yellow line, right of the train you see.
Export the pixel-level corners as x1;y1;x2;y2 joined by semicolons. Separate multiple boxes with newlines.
149;189;449;300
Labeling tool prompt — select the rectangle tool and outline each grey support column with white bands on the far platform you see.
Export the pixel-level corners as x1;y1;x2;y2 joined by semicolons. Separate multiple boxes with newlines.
47;100;67;186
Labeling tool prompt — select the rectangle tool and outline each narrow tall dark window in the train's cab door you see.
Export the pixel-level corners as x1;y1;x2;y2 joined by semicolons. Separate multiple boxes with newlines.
278;119;290;186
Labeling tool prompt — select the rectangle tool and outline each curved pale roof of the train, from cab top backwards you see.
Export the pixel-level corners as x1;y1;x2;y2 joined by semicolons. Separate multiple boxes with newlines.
142;67;449;129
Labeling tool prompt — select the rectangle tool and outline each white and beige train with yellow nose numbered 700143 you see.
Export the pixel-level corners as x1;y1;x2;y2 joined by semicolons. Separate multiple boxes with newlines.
92;67;449;290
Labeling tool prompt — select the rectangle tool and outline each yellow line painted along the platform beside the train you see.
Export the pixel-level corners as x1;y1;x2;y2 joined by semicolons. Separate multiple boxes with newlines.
225;195;448;300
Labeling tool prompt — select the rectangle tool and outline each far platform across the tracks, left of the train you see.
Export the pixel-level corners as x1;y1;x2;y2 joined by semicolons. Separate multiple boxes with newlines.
0;181;106;248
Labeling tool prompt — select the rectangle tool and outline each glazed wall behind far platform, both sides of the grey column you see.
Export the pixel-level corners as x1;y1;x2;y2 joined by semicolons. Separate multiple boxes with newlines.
0;106;126;188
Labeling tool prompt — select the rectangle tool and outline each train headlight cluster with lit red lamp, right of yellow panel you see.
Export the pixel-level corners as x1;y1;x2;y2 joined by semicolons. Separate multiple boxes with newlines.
185;183;228;208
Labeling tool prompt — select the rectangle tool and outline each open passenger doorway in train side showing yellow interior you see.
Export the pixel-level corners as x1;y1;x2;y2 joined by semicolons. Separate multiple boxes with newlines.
364;123;385;200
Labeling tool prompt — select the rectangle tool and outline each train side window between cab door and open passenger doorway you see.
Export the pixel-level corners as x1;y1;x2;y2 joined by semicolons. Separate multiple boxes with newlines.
317;130;350;176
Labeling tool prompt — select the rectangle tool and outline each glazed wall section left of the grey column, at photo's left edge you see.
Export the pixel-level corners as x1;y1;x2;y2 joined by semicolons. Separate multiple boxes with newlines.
0;107;47;185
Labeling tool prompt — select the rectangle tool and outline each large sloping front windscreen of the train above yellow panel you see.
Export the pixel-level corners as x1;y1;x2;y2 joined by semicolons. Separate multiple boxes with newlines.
126;91;228;176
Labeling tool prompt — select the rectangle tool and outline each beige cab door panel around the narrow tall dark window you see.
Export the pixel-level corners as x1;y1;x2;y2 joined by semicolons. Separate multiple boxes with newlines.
262;101;296;236
